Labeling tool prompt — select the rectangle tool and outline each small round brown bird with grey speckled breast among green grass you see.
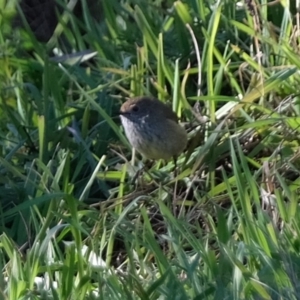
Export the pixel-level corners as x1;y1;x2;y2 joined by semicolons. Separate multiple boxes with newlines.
120;97;187;160
